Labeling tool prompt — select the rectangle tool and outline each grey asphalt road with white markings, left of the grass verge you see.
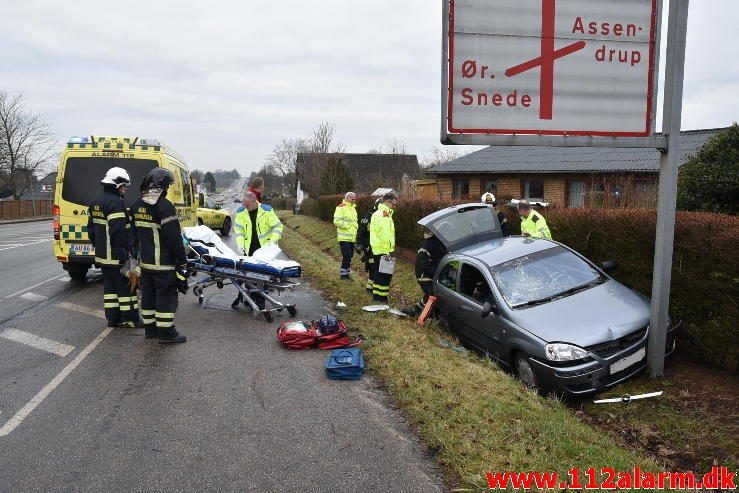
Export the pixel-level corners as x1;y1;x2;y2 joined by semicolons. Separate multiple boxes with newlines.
0;220;443;492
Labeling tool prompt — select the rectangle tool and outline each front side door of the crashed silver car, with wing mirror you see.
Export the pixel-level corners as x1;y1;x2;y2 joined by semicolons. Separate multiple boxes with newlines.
456;262;505;358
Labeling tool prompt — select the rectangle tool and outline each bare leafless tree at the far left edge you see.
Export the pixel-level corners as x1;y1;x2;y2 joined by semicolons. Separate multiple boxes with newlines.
0;91;56;199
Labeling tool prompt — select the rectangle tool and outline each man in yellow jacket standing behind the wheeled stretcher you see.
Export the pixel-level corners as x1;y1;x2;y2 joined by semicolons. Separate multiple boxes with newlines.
231;192;282;309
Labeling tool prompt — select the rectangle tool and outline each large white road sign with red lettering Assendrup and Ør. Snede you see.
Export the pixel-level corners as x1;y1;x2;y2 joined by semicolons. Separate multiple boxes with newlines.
444;0;659;137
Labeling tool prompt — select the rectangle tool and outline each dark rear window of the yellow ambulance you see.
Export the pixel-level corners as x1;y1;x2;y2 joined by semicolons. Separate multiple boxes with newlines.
62;157;157;207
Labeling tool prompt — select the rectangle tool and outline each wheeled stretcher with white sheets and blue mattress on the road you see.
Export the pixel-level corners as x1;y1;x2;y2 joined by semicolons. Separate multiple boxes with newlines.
182;226;301;322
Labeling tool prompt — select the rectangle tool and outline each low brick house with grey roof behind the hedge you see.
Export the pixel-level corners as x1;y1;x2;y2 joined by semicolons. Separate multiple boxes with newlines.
426;128;726;207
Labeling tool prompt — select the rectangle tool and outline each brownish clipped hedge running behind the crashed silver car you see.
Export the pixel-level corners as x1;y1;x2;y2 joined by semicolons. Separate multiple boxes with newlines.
303;196;739;370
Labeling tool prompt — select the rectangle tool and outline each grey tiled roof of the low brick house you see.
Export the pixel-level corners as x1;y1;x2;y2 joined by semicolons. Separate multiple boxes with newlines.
427;128;726;175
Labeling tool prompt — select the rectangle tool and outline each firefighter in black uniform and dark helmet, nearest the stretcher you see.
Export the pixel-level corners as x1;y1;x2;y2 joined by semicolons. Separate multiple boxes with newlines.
131;167;187;344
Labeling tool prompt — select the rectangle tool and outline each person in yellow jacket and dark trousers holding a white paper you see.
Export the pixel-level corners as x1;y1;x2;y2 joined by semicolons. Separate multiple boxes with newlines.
370;193;398;303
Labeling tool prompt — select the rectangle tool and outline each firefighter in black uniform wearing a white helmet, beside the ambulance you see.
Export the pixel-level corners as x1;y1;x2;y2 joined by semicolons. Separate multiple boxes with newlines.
87;167;141;328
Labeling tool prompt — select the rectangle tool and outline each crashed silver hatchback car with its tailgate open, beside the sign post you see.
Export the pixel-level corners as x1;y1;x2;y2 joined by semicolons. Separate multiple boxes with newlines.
418;204;676;396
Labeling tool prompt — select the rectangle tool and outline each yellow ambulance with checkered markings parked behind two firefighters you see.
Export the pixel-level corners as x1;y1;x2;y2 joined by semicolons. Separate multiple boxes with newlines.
54;135;198;281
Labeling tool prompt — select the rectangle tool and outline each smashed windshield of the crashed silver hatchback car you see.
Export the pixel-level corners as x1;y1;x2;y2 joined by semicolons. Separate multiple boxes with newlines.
491;247;605;308
